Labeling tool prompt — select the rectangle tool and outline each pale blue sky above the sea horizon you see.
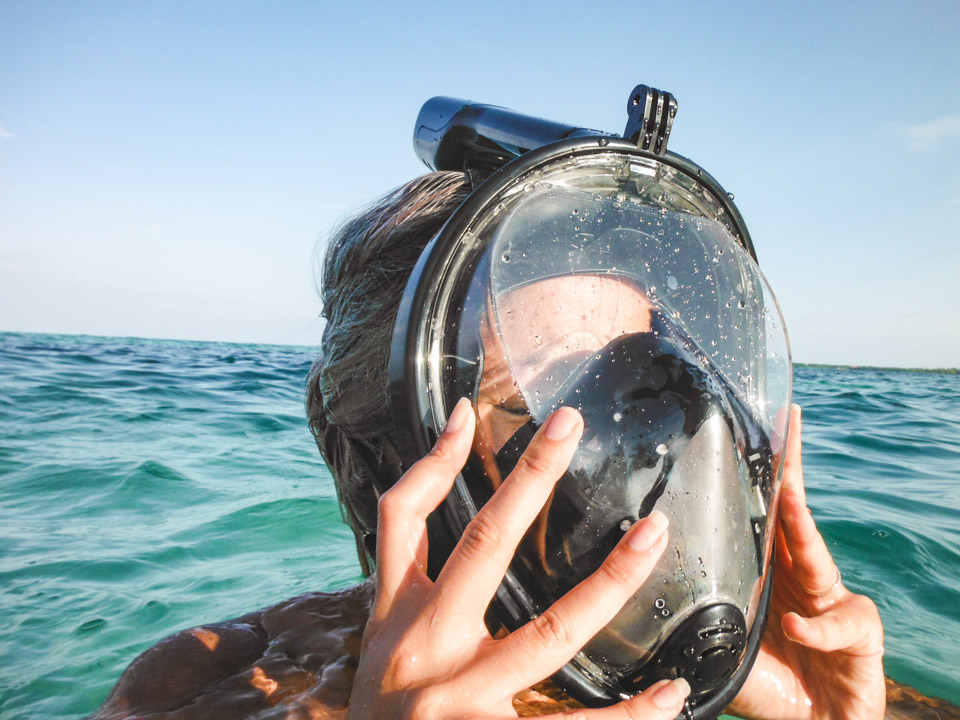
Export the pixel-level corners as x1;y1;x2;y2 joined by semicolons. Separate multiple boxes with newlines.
0;0;960;367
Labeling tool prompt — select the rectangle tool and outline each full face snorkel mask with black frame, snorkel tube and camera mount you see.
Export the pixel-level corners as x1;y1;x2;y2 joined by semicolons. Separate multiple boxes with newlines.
378;85;792;718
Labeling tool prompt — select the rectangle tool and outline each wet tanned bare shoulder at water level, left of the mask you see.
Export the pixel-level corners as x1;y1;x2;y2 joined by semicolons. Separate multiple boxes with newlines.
93;581;373;720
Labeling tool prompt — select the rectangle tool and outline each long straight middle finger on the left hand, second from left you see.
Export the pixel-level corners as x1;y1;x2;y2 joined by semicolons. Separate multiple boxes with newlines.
437;408;583;615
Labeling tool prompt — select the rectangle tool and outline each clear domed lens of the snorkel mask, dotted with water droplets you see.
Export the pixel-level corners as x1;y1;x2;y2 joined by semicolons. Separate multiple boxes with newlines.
425;153;791;692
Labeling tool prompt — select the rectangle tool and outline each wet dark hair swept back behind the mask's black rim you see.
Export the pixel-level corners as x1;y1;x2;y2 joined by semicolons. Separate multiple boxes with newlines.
306;172;471;575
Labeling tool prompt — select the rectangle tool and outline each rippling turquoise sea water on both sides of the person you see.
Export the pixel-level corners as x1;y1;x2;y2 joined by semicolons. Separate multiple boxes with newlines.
0;334;960;720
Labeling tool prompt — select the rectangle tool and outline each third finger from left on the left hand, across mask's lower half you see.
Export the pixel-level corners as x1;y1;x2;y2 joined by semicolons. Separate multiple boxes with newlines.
480;511;667;688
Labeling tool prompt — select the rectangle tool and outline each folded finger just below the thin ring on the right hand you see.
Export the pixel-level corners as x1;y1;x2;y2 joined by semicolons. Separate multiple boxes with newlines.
780;594;883;656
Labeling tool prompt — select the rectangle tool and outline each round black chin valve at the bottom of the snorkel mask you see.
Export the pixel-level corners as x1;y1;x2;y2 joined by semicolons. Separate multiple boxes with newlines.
641;603;747;706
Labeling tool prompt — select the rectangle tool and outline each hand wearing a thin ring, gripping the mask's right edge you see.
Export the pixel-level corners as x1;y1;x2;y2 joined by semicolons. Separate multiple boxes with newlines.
727;405;886;720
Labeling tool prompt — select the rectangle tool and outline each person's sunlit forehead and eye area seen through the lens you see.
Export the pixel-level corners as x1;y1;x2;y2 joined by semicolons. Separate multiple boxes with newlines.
477;275;653;453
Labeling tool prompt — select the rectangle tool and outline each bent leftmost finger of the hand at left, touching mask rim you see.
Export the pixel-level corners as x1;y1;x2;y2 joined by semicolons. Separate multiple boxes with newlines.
377;398;476;606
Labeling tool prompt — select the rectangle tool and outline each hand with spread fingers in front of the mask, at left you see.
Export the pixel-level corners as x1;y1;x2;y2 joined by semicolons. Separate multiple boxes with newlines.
348;400;689;720
